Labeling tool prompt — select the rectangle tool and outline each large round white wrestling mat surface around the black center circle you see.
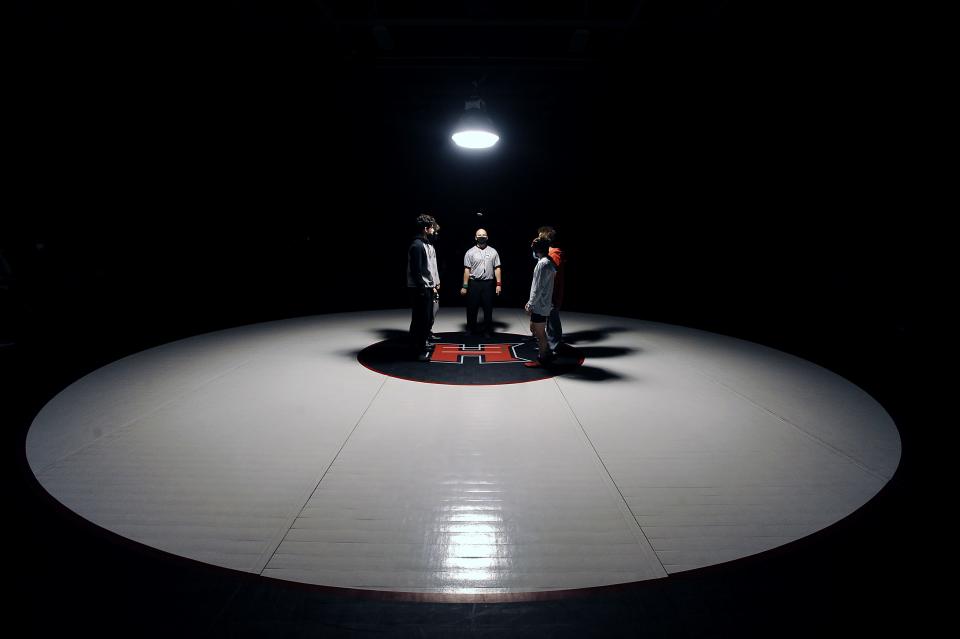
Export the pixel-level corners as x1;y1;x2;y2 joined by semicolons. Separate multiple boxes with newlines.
27;308;900;600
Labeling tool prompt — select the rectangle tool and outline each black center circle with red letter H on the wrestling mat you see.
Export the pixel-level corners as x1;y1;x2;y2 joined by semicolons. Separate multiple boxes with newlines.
357;333;583;385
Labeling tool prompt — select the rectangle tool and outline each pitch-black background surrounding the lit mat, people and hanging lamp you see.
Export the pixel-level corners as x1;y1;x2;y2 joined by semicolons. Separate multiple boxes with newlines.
0;2;933;636
